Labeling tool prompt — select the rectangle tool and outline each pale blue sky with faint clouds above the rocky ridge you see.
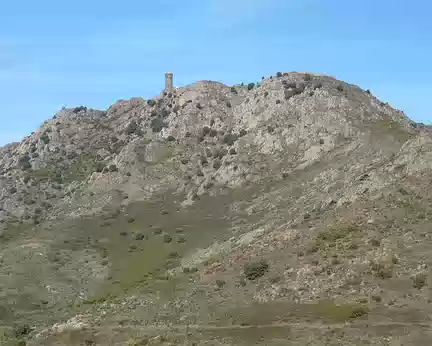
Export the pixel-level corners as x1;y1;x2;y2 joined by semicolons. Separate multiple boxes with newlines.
0;0;432;145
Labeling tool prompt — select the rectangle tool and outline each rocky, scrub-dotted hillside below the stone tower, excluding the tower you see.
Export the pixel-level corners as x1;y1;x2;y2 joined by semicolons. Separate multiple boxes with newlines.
0;72;432;346
